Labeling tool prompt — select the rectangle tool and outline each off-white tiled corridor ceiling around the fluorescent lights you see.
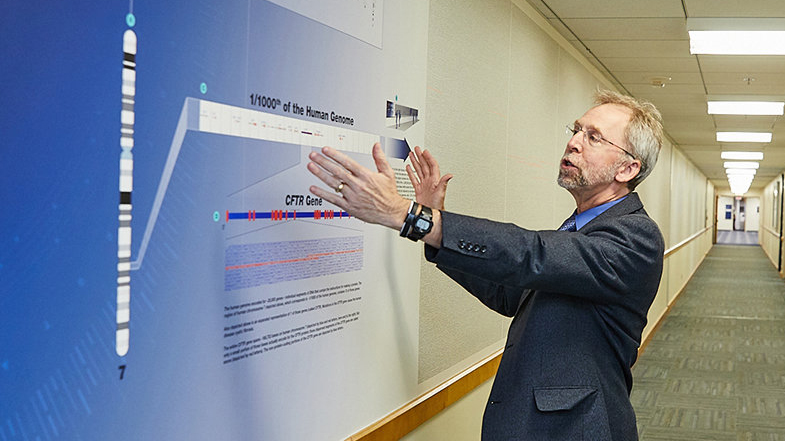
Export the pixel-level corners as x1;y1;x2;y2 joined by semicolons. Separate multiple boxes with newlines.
527;0;785;191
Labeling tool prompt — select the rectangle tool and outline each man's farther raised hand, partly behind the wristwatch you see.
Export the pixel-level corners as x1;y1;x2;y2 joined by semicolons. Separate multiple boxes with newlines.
406;146;453;210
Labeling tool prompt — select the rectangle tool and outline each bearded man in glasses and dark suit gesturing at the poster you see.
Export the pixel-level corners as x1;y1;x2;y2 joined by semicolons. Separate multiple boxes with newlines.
308;92;664;441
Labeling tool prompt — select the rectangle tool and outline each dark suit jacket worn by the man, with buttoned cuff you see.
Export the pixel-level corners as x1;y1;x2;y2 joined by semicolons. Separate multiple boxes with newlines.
426;193;664;441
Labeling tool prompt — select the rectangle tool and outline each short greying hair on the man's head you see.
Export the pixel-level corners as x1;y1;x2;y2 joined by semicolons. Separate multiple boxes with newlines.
594;90;662;190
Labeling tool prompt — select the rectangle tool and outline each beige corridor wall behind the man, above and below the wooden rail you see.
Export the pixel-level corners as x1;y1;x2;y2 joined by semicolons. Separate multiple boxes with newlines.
404;0;714;441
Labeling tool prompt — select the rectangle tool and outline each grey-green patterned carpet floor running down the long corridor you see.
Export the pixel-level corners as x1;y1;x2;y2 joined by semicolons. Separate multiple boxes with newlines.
631;245;785;441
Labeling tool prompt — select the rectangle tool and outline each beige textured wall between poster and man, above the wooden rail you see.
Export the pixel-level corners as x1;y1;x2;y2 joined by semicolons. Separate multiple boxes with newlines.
419;0;604;383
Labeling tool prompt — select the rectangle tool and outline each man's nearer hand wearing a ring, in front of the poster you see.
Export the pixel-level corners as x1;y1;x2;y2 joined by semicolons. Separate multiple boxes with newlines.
308;143;410;230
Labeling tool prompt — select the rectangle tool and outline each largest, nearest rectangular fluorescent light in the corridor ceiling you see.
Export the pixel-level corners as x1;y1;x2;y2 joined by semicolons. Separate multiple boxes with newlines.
689;31;785;55
